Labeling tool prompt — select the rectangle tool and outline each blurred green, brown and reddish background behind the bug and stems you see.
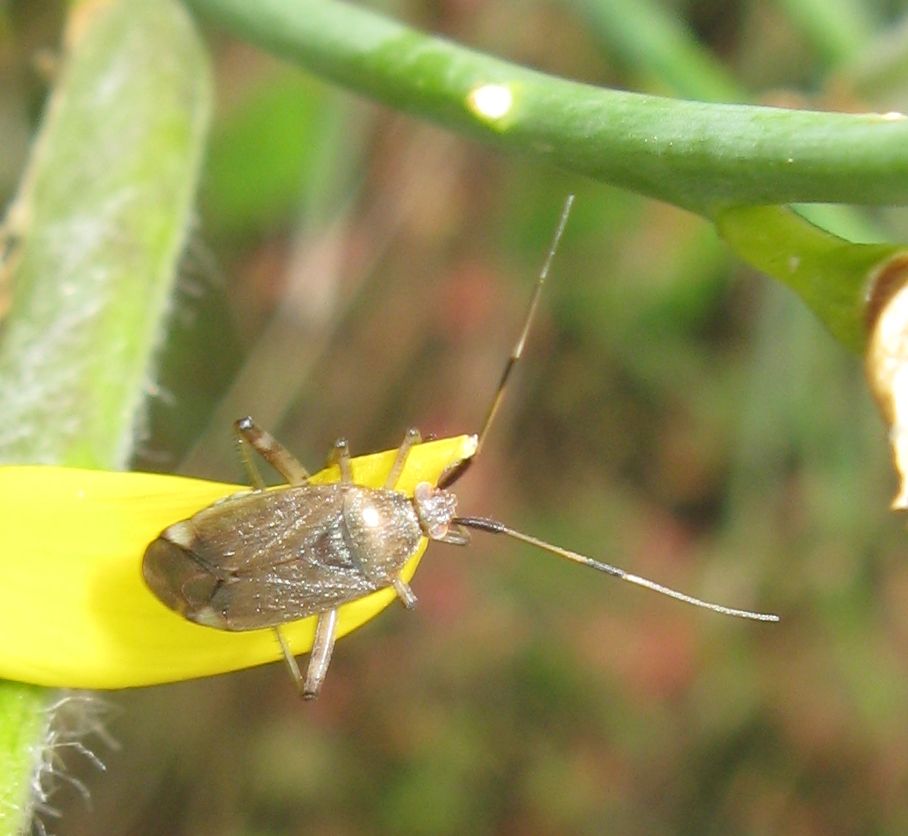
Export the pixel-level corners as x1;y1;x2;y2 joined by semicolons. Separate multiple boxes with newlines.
0;0;908;836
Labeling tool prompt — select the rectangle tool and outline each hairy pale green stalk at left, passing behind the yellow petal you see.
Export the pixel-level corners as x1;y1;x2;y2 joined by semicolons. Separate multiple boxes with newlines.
0;0;210;835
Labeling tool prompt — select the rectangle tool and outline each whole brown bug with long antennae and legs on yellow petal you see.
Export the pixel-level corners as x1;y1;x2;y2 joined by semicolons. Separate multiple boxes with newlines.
142;195;778;699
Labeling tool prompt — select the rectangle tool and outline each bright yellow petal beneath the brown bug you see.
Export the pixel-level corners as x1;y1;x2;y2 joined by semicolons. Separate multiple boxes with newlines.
0;436;476;688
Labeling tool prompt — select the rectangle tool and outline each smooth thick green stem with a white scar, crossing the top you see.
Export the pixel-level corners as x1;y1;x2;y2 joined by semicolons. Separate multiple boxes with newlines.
187;0;908;216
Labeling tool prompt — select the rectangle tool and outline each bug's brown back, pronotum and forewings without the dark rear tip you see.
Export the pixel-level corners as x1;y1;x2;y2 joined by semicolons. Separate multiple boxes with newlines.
172;485;420;631
